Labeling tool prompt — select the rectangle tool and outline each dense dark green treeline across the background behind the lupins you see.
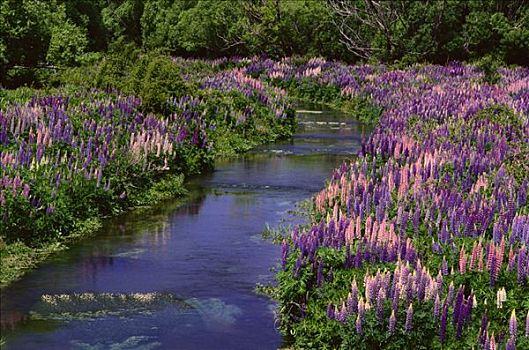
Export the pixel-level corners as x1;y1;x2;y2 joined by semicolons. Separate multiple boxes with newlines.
0;0;529;86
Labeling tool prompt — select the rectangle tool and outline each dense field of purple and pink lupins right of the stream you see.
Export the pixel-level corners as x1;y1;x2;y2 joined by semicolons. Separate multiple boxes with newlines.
274;60;529;349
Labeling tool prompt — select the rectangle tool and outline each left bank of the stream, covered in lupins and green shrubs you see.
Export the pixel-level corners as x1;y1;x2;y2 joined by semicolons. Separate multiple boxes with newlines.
0;55;294;284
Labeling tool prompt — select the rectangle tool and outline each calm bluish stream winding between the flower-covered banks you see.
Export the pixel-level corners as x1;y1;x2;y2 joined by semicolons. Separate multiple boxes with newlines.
0;105;369;350
